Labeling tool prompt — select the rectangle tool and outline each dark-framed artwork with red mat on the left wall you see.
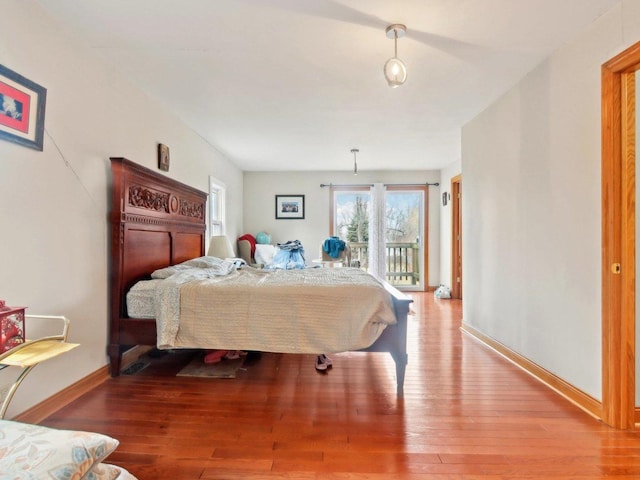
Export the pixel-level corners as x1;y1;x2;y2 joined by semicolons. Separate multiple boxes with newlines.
0;65;47;151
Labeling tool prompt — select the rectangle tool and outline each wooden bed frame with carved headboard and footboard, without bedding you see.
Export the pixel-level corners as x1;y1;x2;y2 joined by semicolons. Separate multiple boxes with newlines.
107;158;412;395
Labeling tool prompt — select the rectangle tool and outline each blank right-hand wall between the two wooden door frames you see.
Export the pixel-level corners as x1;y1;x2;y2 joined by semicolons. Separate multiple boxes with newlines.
462;1;640;399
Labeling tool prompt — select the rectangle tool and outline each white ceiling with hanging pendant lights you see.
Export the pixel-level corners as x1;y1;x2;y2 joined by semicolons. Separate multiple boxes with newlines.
36;0;620;171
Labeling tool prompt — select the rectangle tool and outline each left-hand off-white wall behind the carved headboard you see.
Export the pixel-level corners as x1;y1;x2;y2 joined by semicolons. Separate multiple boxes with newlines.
0;0;243;417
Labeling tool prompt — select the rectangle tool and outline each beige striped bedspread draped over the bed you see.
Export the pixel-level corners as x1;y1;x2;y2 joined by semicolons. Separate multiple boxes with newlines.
155;268;396;353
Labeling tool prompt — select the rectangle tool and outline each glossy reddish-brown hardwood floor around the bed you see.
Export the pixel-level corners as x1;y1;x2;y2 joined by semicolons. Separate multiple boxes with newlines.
42;293;640;480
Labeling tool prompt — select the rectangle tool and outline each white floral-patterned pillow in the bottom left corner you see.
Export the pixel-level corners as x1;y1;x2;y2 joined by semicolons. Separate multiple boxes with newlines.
0;420;119;480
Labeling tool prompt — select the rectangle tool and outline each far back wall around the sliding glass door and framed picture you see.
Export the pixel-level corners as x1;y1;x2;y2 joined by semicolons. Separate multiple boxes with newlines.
243;170;440;286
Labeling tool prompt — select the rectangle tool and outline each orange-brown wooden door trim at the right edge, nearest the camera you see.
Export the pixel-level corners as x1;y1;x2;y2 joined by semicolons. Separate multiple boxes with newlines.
602;42;640;429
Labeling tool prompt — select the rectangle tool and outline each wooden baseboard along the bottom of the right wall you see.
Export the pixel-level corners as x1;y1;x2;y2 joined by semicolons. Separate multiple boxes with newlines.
460;322;604;420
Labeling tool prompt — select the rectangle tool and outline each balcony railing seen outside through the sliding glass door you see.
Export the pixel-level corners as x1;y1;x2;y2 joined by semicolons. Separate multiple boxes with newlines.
349;242;420;286
